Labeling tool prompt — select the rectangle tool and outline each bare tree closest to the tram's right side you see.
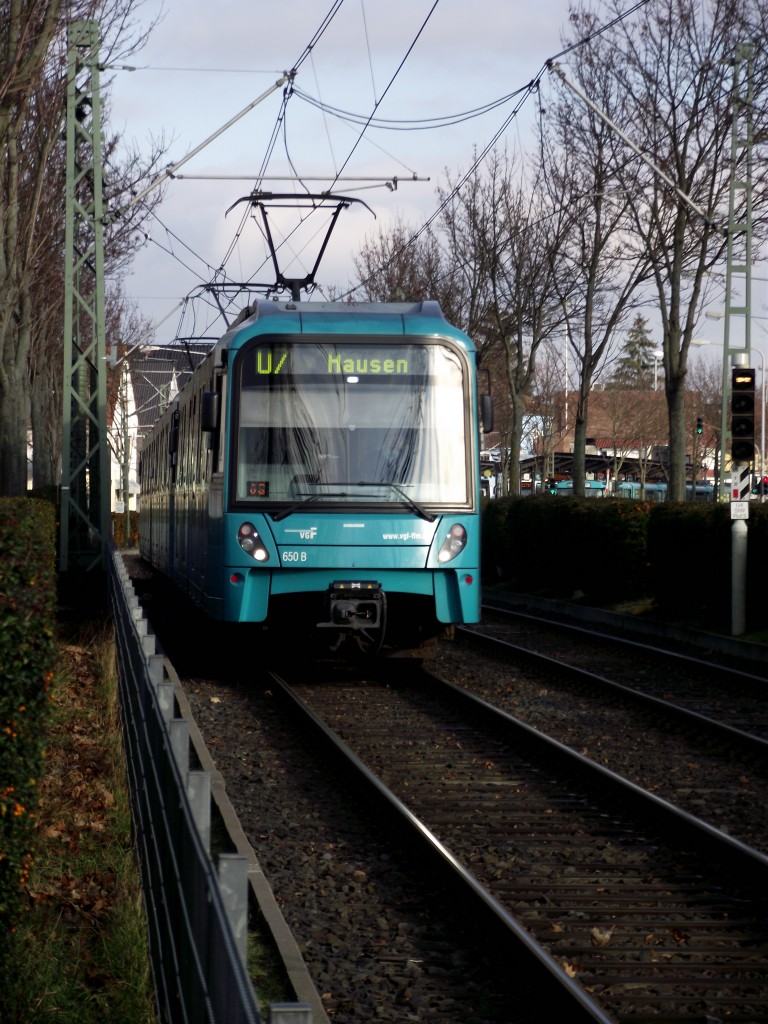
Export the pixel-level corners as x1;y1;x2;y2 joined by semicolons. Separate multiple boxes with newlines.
356;153;577;494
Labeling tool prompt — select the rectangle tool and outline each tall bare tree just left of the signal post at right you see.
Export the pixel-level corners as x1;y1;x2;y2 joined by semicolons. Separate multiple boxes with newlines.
571;0;768;500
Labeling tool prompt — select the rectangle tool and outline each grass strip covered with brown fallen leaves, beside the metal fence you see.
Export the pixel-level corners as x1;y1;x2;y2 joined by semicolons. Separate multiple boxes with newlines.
0;629;157;1024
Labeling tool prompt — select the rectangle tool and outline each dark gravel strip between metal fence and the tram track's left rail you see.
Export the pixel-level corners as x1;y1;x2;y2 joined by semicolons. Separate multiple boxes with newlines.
183;670;518;1024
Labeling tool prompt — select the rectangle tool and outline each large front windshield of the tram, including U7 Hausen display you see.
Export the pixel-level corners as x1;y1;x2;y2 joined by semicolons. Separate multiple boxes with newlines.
233;338;471;514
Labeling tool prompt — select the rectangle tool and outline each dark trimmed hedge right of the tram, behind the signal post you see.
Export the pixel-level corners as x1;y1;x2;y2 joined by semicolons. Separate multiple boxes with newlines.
482;497;768;632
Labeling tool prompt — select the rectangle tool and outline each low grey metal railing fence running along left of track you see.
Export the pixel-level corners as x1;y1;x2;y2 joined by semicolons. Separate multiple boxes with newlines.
109;551;274;1024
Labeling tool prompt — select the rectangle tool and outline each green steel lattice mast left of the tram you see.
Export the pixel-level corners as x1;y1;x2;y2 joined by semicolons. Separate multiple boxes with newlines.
59;19;112;572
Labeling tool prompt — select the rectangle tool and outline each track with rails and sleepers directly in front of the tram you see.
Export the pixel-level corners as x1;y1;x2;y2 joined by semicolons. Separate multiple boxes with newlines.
287;667;768;1022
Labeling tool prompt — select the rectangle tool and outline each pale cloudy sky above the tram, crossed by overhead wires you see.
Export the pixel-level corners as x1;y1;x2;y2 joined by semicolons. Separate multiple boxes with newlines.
102;0;593;343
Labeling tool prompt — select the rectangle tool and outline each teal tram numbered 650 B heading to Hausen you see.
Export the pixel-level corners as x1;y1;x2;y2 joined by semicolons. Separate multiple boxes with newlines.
139;301;492;654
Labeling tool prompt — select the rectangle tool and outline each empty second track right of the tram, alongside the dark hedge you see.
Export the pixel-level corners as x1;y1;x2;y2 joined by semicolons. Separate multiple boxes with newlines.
437;602;768;852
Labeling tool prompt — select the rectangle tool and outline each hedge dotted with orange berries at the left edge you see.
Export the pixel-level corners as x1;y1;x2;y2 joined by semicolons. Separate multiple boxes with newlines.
0;498;56;942
